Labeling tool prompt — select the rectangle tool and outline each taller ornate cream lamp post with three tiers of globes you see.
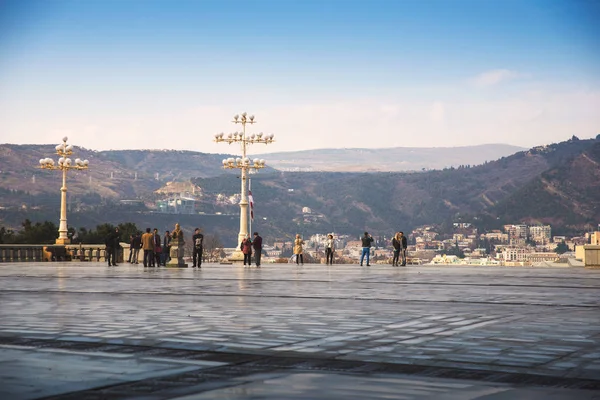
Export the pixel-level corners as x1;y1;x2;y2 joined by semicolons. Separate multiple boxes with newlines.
215;113;274;260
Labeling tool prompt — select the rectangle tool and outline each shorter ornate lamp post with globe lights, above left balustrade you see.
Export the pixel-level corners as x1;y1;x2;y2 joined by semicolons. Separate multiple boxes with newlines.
40;136;89;244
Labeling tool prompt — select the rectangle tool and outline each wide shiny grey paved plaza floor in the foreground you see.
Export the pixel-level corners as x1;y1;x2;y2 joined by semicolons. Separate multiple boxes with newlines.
0;262;600;400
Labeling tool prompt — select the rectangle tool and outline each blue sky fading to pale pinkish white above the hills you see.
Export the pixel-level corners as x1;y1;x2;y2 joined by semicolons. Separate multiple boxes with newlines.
0;0;600;155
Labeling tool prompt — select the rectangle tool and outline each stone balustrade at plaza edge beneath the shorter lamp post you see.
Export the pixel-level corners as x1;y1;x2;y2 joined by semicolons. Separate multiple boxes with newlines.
0;244;110;262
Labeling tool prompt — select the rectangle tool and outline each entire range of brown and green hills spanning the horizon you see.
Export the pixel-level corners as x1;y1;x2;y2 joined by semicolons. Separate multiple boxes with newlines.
0;137;600;245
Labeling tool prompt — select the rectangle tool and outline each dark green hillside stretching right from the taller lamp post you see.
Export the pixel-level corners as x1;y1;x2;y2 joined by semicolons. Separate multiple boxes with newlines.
189;140;600;241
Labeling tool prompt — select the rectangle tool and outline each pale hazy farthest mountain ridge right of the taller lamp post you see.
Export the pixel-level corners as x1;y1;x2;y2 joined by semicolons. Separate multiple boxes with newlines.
261;144;525;172
